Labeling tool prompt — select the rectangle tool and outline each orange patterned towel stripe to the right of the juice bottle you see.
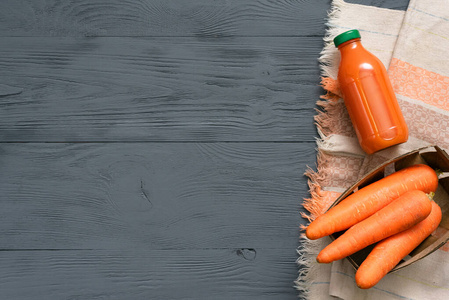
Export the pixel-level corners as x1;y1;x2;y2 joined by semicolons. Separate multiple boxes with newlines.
388;58;449;111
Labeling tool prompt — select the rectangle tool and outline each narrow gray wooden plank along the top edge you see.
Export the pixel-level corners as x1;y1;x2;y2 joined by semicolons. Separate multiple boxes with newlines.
0;0;329;37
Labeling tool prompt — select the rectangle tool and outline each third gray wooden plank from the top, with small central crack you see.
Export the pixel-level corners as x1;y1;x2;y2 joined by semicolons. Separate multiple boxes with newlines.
0;143;316;252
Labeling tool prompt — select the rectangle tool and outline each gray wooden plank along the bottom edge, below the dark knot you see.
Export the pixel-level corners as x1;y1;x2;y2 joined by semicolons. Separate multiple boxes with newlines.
0;245;296;300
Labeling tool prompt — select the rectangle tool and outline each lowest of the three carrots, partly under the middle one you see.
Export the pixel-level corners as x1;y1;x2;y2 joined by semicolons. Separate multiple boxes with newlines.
355;201;442;289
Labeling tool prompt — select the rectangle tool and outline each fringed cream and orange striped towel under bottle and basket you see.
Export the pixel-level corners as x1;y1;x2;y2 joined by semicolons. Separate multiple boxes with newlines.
296;0;449;300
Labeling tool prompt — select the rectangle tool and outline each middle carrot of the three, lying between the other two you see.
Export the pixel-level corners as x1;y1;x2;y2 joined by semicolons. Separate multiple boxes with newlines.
317;190;432;263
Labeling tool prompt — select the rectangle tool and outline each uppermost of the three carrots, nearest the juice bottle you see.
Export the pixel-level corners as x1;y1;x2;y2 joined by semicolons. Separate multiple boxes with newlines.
306;164;438;240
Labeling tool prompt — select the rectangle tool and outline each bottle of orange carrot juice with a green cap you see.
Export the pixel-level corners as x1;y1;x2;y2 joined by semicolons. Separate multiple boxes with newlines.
334;30;408;154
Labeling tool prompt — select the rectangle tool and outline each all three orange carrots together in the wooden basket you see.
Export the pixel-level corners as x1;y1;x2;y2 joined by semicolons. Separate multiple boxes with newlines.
306;164;442;289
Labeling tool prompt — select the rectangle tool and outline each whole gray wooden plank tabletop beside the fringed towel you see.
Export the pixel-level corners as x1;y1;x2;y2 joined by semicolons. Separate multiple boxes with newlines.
0;0;408;299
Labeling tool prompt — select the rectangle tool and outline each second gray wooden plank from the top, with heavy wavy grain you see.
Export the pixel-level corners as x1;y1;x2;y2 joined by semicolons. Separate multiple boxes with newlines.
0;37;322;142
